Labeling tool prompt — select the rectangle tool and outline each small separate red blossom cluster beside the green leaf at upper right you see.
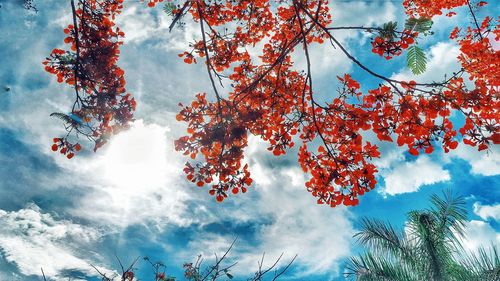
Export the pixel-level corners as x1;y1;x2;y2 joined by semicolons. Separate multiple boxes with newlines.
372;29;418;60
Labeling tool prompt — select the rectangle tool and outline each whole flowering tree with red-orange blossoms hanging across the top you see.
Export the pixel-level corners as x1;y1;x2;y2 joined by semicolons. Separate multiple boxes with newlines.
44;0;500;207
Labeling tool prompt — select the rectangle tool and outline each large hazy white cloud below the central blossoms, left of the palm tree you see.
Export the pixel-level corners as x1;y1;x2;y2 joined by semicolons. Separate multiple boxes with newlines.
182;137;354;278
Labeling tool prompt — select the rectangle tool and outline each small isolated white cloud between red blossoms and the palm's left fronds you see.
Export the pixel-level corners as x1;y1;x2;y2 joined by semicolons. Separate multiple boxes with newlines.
382;156;450;195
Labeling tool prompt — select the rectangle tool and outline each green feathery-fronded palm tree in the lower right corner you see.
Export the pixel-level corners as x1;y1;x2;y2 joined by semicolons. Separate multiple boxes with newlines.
344;192;500;281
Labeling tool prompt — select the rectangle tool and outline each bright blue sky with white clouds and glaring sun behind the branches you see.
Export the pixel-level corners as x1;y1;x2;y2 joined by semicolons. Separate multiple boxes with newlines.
0;0;500;281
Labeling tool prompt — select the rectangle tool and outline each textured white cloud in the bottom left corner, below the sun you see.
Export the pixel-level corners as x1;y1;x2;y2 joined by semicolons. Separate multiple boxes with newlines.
0;205;112;278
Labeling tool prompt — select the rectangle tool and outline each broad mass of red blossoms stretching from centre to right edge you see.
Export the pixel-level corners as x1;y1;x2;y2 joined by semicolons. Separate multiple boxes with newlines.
167;0;499;207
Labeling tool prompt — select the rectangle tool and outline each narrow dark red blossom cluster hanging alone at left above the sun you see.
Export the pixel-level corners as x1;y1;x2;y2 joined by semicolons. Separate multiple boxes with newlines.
43;0;136;158
